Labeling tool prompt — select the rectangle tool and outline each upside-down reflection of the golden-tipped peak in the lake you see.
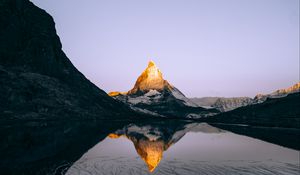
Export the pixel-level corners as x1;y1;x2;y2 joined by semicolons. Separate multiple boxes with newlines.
108;122;223;172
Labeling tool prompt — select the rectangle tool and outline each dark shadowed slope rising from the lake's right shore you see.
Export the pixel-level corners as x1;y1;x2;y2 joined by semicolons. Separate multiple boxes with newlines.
203;92;300;129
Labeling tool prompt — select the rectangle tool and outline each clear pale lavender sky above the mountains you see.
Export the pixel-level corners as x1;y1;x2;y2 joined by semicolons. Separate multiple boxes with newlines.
31;0;299;97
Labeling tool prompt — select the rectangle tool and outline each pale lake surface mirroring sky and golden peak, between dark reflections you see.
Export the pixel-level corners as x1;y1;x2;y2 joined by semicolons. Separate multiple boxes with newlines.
66;122;300;175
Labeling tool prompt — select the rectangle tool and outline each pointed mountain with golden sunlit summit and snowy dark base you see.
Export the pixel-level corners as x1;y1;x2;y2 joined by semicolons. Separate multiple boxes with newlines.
109;61;218;118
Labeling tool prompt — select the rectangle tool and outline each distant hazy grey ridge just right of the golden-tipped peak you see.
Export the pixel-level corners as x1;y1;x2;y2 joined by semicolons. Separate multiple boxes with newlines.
191;97;254;112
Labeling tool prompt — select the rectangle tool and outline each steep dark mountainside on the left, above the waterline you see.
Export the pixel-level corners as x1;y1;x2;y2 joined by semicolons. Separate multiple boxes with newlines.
0;0;140;119
